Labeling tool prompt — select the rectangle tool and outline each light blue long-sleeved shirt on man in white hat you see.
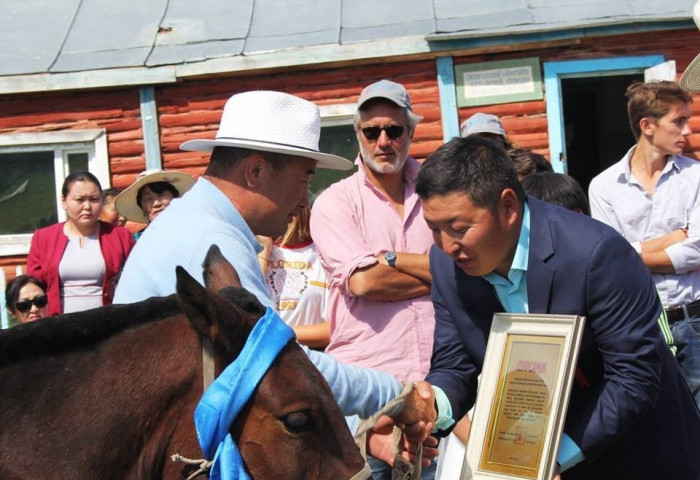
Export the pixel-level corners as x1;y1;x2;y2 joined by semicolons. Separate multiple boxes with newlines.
114;178;402;418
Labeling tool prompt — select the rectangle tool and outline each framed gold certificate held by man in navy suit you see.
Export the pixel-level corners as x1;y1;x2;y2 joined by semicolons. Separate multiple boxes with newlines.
460;313;585;480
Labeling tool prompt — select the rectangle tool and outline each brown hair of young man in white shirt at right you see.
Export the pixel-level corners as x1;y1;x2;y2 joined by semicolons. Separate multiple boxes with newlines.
625;80;693;140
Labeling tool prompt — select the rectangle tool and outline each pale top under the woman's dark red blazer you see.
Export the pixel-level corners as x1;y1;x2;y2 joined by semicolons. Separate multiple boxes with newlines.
58;235;105;313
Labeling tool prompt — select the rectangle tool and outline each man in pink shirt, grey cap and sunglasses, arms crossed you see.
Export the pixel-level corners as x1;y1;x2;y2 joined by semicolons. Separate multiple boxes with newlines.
311;80;435;479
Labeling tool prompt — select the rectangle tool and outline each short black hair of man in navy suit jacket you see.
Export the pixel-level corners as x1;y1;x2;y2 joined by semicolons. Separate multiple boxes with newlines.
416;135;525;208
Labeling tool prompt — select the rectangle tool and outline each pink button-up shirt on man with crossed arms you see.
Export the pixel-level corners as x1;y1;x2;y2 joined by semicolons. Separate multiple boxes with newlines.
311;156;435;382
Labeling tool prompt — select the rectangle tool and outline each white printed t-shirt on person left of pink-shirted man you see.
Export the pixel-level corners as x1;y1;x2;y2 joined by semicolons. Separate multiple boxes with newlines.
265;243;328;327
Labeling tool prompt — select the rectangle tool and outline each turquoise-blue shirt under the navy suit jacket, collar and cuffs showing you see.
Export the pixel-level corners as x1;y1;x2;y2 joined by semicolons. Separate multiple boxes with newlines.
433;203;584;472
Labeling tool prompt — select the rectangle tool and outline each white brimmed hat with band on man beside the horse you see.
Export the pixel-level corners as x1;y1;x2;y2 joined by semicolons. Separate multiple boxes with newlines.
180;90;353;170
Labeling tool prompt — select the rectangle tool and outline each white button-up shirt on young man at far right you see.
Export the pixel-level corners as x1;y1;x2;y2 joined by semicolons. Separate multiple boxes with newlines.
588;147;700;308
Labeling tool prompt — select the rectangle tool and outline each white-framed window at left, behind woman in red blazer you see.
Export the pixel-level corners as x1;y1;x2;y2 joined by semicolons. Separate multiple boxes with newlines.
0;130;109;256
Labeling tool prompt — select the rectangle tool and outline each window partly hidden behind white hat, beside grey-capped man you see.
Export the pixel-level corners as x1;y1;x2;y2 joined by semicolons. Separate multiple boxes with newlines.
309;103;359;202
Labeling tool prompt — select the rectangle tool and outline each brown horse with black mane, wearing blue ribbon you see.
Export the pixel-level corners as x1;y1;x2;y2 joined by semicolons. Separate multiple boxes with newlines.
0;249;364;480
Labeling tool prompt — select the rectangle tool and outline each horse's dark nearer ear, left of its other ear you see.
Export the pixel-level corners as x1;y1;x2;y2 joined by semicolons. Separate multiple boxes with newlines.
175;265;216;338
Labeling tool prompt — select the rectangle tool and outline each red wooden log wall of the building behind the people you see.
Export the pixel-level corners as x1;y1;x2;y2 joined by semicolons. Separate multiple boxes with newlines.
0;29;700;278
